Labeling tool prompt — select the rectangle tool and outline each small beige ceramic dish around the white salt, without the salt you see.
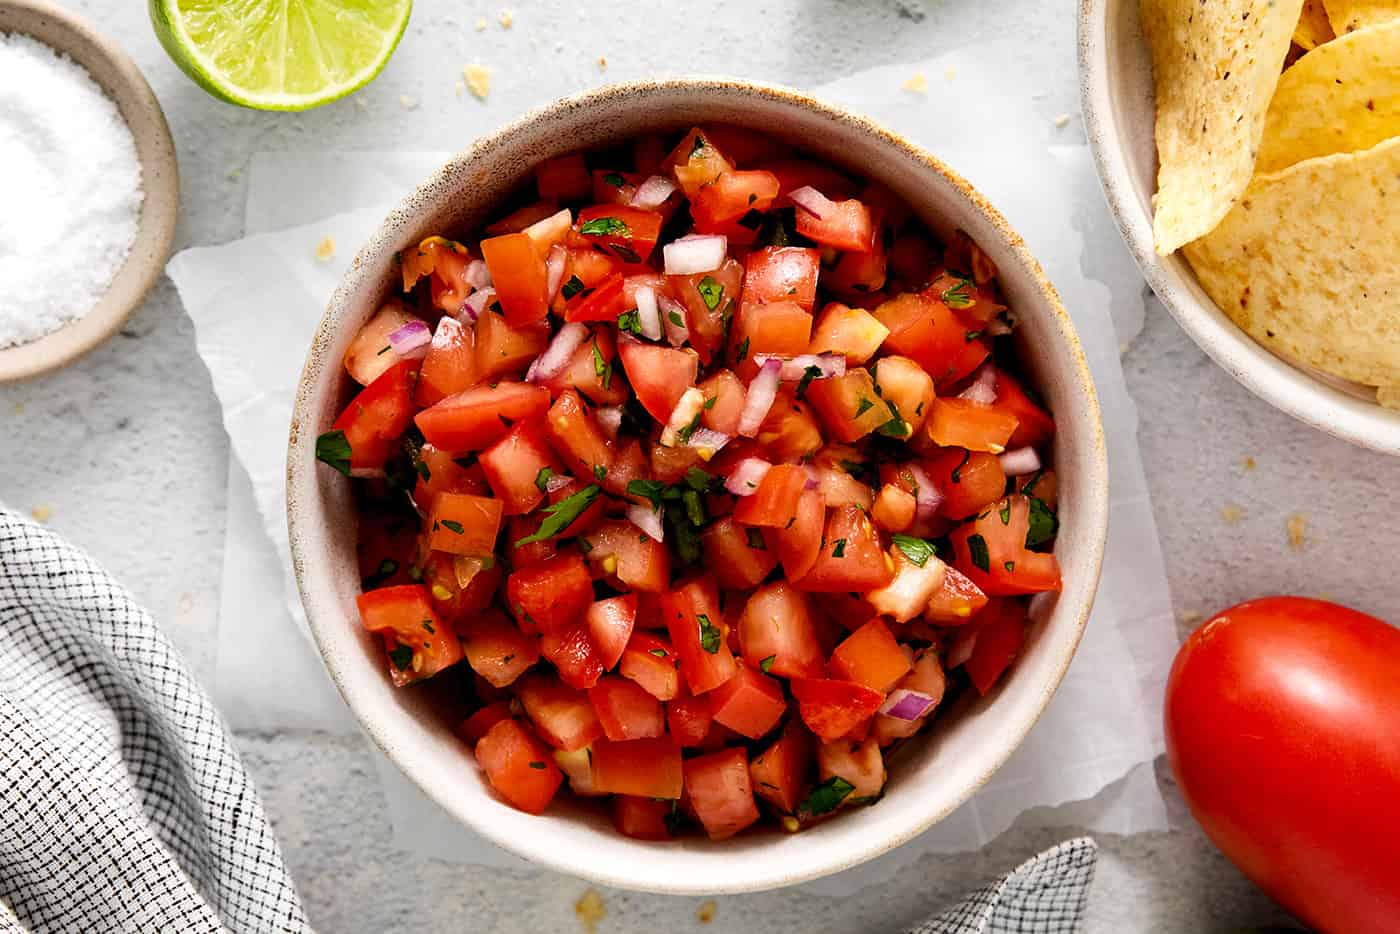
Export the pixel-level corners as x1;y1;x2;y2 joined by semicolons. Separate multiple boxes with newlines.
0;0;179;382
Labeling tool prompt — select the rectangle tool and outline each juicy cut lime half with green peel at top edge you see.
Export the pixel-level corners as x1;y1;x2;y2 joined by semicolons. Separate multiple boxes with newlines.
150;0;413;111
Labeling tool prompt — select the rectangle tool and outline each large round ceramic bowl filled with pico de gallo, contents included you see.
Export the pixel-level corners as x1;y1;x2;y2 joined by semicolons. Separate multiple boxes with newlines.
287;78;1107;893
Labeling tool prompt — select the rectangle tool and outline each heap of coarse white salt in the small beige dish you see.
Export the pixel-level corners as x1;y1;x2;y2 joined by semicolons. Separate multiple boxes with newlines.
0;32;143;349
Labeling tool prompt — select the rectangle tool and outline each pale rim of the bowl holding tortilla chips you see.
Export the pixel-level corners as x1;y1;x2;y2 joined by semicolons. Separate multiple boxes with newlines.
1077;0;1400;455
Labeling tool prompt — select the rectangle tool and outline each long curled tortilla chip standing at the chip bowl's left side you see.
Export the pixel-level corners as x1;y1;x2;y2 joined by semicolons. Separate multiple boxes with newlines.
1141;0;1303;256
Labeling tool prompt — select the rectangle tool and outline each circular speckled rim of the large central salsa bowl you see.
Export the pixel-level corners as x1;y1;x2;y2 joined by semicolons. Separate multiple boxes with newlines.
287;76;1109;895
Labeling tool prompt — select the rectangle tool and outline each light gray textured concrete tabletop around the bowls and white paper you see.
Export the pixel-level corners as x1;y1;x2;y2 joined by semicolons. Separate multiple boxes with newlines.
0;0;1377;934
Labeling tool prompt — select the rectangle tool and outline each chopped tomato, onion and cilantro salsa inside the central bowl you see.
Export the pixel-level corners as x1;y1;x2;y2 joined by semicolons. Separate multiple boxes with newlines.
316;125;1060;840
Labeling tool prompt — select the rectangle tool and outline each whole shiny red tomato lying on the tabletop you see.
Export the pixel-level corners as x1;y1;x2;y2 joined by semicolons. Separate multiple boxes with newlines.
1166;597;1400;934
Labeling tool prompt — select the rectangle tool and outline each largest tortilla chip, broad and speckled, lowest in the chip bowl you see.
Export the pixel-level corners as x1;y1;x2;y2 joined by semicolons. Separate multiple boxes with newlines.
1183;139;1400;385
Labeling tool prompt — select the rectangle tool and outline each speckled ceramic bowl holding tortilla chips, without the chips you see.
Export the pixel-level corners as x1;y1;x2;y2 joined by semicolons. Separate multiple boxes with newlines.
1079;0;1400;454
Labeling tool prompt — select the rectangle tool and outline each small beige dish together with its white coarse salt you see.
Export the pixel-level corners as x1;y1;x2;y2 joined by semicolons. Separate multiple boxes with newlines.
0;0;179;382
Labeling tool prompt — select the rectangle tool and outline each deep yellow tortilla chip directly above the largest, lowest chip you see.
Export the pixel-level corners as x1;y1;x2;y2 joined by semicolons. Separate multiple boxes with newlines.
1254;20;1400;174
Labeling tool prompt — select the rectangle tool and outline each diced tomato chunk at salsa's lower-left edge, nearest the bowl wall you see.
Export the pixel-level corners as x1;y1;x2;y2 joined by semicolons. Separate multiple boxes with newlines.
356;584;462;688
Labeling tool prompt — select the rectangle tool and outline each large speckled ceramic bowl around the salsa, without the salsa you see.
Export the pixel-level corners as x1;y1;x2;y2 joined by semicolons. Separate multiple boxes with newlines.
287;78;1107;895
